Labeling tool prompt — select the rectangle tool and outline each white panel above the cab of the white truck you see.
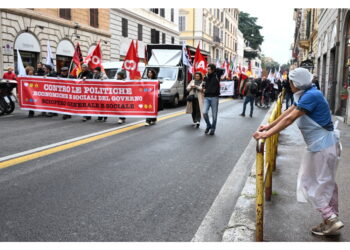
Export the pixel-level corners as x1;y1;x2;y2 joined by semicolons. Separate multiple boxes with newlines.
148;49;182;66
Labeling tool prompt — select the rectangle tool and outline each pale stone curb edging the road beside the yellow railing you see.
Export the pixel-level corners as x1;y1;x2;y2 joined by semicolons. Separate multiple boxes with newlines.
222;104;276;242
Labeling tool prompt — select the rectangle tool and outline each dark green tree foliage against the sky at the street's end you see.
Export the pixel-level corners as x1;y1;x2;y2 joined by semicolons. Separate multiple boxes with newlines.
238;12;264;49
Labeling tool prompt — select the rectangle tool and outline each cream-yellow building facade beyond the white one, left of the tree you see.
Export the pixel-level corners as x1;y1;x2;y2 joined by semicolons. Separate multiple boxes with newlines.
179;8;239;63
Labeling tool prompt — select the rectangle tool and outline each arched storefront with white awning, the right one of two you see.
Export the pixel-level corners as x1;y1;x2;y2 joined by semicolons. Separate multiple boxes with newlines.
56;40;74;73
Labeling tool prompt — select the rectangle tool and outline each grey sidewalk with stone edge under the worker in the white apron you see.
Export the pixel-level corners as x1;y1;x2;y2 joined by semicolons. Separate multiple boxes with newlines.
223;114;350;242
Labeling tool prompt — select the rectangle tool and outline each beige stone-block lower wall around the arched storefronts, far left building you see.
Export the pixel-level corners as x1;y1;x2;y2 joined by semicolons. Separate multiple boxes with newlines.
0;9;111;74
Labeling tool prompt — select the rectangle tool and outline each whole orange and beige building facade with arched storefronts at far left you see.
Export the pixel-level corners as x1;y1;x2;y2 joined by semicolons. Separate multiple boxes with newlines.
0;9;111;74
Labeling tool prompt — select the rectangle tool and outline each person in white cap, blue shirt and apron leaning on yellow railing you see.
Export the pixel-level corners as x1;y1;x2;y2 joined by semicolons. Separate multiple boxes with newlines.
253;68;344;236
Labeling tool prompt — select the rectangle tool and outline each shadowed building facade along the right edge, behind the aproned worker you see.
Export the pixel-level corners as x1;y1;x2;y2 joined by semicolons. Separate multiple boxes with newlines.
292;9;350;124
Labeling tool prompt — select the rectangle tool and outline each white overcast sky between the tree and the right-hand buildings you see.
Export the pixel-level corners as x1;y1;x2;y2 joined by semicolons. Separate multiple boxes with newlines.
239;5;295;64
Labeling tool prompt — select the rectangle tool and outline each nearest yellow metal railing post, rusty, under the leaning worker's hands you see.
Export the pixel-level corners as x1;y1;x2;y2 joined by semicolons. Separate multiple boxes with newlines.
255;140;264;241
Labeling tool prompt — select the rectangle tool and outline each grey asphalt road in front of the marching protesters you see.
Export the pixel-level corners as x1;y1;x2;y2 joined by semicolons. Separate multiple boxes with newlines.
0;100;266;241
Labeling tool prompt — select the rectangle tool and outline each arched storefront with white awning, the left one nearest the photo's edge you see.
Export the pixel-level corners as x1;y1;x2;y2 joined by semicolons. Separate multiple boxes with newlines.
14;32;40;73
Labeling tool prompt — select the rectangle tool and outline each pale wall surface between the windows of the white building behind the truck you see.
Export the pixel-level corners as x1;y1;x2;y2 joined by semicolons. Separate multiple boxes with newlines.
110;8;179;60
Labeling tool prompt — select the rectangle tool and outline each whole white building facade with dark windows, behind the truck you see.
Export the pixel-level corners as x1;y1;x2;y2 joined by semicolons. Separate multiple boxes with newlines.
110;8;179;61
